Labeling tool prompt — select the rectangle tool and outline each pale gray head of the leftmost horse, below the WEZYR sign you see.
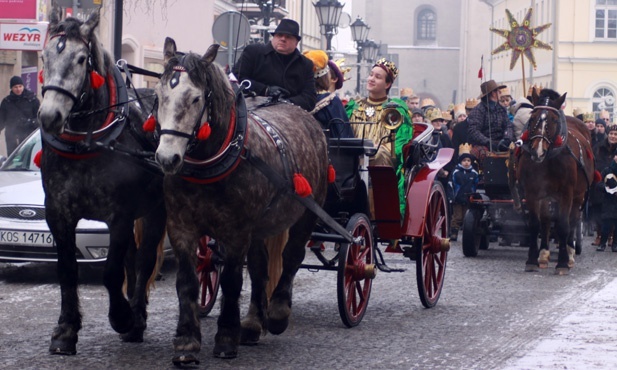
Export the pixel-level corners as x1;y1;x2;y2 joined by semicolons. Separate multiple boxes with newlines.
38;6;111;134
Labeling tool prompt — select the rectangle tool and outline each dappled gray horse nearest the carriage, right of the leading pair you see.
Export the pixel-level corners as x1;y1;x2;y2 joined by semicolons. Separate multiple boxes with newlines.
155;38;328;364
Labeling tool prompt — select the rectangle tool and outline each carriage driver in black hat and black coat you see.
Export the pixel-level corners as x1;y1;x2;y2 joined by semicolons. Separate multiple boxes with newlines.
233;19;317;112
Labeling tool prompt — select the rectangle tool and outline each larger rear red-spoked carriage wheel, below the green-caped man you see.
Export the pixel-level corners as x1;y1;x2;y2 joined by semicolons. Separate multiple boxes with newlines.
414;181;450;308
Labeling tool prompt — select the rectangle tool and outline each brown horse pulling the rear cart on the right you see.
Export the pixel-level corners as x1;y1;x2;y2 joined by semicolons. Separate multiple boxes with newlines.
514;89;595;275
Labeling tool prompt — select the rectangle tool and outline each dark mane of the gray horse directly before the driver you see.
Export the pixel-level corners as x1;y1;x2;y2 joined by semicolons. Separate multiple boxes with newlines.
161;53;234;129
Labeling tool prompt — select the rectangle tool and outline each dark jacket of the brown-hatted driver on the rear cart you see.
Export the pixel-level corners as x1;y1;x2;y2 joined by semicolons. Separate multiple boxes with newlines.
467;99;514;148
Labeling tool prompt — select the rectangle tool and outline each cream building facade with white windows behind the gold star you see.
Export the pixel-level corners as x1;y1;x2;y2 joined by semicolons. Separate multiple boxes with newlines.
467;0;617;120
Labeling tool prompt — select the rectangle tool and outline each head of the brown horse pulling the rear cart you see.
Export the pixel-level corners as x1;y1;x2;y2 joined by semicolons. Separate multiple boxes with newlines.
523;89;566;163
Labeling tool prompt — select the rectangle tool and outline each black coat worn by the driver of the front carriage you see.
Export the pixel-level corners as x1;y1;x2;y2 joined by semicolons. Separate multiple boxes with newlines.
233;43;317;112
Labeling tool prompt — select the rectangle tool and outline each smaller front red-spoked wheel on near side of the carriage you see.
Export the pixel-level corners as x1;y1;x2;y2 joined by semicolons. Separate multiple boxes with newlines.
337;213;376;328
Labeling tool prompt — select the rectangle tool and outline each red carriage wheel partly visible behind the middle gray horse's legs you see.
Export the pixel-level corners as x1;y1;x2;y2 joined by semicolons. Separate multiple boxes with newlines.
197;236;223;317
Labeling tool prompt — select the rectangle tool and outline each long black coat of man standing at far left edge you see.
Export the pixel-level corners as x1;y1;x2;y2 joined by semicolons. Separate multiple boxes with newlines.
0;89;41;154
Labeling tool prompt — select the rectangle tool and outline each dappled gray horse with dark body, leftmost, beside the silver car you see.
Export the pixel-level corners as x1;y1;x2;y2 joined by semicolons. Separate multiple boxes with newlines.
38;7;166;354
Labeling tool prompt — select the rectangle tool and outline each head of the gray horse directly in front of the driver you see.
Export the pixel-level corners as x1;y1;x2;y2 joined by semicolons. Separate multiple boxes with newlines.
155;37;234;174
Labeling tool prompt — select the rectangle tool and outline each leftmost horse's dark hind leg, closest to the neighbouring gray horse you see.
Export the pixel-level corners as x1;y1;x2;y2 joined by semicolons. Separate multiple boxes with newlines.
121;207;166;342
